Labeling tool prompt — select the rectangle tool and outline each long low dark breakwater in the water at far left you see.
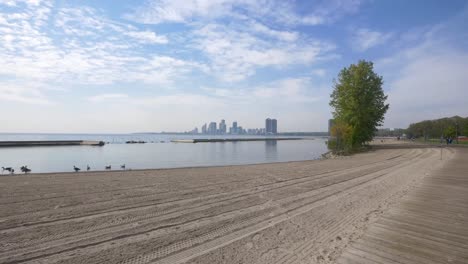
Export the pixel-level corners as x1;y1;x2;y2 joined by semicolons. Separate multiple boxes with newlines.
0;140;105;148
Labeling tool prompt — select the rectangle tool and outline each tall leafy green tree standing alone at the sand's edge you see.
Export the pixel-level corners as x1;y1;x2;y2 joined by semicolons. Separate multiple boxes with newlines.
330;60;389;149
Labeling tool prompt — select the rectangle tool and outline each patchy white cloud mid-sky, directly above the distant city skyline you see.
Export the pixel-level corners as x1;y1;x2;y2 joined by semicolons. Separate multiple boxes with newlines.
193;24;335;82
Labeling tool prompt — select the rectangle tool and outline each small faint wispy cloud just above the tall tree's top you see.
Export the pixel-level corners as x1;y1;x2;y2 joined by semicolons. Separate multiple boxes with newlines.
352;28;393;52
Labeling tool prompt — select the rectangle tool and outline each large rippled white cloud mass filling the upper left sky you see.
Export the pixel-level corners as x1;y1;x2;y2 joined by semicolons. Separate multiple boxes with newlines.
0;1;201;95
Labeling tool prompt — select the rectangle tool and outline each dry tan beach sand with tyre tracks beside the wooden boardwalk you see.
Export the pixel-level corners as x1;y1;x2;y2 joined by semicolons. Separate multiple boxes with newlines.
0;148;454;264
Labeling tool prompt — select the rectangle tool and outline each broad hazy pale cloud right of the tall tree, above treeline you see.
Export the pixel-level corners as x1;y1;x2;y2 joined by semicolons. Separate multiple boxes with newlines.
385;50;468;127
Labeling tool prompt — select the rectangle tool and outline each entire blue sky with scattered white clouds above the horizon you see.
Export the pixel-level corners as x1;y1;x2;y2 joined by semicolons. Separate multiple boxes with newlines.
0;0;468;133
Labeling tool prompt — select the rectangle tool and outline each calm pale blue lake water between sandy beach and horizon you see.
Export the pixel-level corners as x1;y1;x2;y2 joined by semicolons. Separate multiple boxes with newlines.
0;134;327;174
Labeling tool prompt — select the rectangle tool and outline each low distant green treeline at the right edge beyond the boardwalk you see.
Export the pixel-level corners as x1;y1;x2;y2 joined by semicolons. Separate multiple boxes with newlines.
406;116;468;138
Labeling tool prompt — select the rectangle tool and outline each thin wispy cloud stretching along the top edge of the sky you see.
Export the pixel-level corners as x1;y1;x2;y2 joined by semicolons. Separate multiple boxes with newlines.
125;0;362;25
